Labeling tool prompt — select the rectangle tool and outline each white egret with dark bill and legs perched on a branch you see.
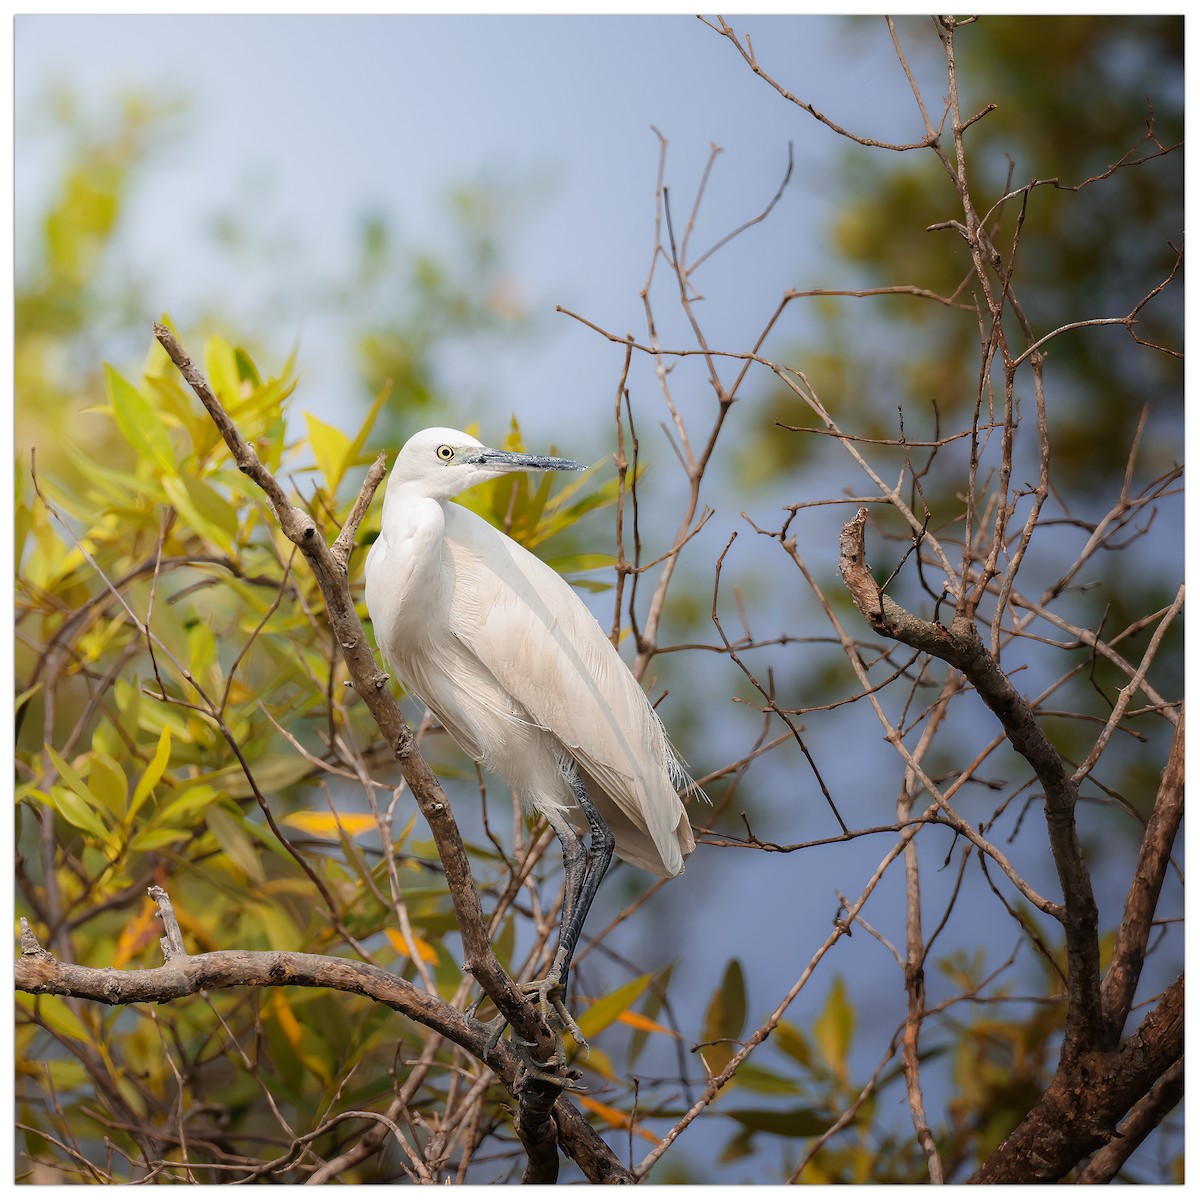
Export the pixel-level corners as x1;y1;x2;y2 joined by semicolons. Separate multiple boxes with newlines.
366;428;696;1051
